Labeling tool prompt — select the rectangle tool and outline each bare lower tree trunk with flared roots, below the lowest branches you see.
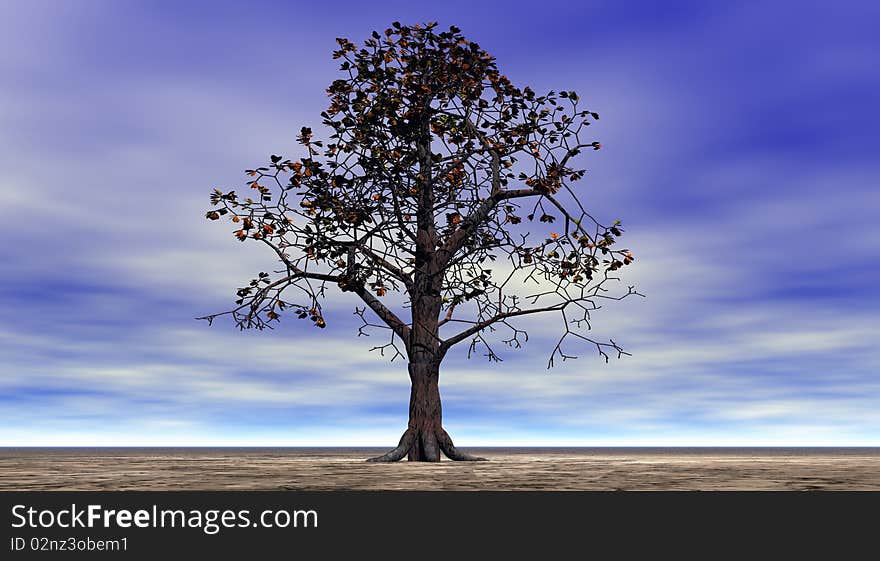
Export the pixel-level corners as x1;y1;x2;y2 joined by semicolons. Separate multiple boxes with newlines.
367;362;485;462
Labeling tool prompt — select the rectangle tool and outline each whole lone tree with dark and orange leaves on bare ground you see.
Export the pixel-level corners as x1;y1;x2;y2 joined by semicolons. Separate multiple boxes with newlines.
199;22;637;461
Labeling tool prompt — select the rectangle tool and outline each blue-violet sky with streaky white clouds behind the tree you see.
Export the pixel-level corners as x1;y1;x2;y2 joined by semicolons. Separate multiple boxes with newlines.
0;0;880;447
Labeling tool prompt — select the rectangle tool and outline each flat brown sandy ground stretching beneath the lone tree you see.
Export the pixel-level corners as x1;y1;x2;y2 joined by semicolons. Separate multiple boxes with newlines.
0;448;880;491
